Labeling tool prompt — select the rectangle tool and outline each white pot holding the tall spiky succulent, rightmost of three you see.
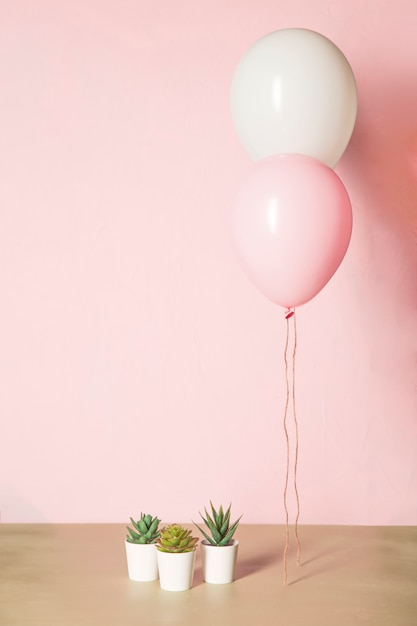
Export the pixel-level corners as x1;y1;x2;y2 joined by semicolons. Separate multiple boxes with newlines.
200;539;239;585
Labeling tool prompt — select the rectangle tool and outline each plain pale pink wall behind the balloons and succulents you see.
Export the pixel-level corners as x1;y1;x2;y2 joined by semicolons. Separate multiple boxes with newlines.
0;0;417;524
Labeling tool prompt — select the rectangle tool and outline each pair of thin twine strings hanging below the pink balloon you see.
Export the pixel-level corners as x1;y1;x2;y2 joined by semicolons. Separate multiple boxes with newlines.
283;309;301;585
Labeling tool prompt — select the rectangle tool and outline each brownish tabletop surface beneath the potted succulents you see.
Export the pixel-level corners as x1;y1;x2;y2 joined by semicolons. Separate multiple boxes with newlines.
0;524;417;626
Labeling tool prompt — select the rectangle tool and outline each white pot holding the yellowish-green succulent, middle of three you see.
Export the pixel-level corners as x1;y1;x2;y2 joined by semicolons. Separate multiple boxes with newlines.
156;550;195;591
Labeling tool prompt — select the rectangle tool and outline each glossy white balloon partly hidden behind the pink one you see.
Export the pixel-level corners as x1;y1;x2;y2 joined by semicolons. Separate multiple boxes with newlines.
231;28;357;167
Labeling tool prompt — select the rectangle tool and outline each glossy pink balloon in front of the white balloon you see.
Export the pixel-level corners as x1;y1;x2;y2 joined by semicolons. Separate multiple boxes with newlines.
231;154;352;308
